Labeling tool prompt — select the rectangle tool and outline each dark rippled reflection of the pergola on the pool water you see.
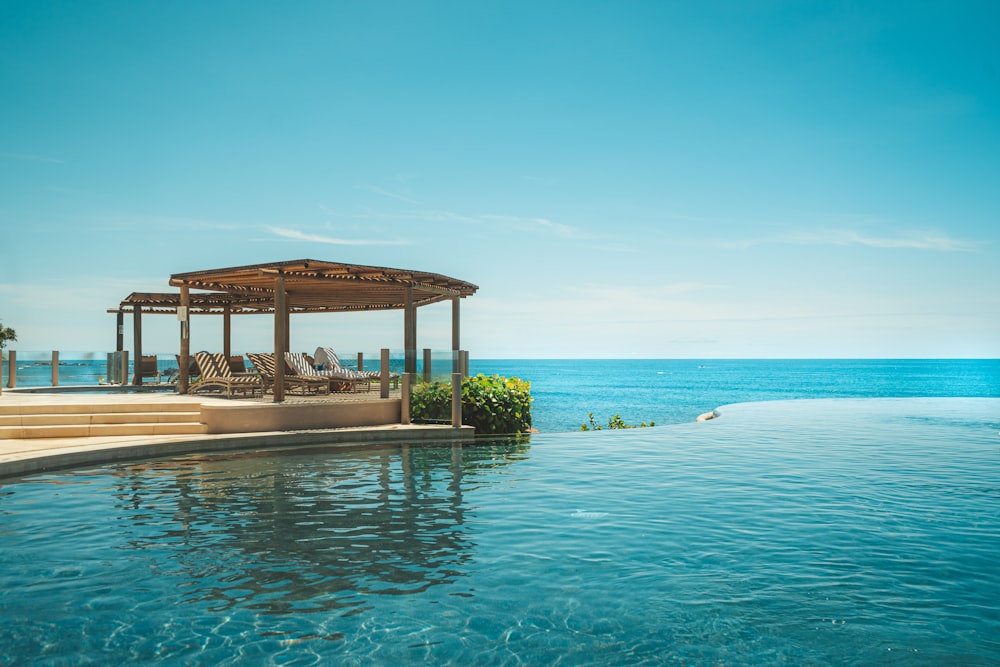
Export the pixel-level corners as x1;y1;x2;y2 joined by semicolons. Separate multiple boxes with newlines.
109;444;526;614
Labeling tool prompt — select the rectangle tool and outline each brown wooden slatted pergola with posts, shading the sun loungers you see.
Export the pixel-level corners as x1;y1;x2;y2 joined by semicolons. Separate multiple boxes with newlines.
111;259;479;402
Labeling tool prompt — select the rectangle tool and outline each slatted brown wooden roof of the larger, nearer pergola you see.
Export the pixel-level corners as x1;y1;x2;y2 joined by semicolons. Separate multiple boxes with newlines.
166;259;479;314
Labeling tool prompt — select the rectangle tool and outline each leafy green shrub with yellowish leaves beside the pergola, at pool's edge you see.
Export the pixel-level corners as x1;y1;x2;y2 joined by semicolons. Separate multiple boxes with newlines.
410;374;532;435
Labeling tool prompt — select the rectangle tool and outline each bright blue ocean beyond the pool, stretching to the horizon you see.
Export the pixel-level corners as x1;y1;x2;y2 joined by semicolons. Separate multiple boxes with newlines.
3;353;1000;433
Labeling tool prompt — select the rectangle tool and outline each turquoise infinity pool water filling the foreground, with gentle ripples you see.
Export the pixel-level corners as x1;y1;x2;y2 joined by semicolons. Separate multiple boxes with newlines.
0;399;1000;665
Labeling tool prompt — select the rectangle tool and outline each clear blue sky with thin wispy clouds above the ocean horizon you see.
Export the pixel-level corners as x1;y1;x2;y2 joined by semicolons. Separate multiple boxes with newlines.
0;0;1000;359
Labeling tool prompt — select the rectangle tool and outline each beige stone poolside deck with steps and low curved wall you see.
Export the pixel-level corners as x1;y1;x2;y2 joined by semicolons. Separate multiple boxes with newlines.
0;390;475;477
